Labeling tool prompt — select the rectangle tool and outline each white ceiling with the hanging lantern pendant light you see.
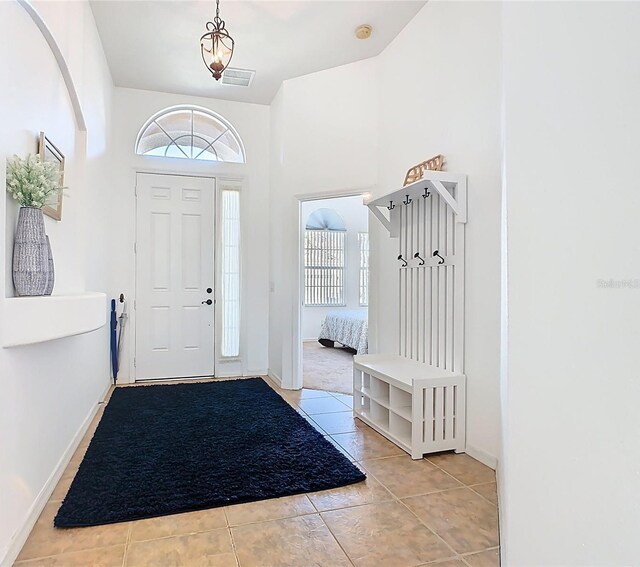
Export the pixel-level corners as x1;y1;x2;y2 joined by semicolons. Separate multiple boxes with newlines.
91;0;426;104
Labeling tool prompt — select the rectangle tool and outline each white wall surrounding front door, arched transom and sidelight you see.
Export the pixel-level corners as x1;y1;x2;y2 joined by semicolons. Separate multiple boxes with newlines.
110;88;270;382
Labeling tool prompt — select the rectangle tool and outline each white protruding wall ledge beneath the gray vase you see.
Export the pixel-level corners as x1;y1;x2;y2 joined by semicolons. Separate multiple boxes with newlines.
2;292;107;348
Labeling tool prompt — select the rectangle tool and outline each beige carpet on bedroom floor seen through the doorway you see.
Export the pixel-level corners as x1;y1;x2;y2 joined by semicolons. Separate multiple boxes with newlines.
302;341;353;394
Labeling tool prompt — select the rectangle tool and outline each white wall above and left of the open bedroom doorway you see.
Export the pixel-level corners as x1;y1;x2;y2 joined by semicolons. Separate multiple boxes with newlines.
269;59;378;387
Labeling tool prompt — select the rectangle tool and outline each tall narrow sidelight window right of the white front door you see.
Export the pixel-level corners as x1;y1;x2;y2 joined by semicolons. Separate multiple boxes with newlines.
220;189;240;357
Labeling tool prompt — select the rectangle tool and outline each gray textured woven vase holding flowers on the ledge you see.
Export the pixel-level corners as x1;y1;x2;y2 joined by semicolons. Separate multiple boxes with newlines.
13;207;53;295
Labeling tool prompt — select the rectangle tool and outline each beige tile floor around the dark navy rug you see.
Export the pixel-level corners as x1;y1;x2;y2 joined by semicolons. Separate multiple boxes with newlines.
15;380;500;567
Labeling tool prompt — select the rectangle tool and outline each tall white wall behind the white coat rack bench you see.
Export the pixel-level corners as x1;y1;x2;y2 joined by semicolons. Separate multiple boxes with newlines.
370;2;501;466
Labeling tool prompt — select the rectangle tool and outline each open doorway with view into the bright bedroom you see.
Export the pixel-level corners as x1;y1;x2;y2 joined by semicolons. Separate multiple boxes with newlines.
300;195;369;394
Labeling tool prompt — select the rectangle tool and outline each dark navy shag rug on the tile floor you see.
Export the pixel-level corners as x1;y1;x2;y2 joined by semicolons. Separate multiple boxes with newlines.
54;378;365;528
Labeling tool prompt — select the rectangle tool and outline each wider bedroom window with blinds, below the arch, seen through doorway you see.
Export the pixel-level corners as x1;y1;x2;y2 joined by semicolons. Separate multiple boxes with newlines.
304;229;345;306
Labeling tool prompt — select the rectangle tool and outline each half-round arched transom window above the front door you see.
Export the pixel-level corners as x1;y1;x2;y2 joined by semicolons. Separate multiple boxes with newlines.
136;106;246;163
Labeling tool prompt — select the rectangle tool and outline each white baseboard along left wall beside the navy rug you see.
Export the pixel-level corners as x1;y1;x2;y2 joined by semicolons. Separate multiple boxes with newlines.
0;383;111;567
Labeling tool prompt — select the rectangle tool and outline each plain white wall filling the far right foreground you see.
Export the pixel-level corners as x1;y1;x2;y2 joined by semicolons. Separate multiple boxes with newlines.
501;2;640;567
